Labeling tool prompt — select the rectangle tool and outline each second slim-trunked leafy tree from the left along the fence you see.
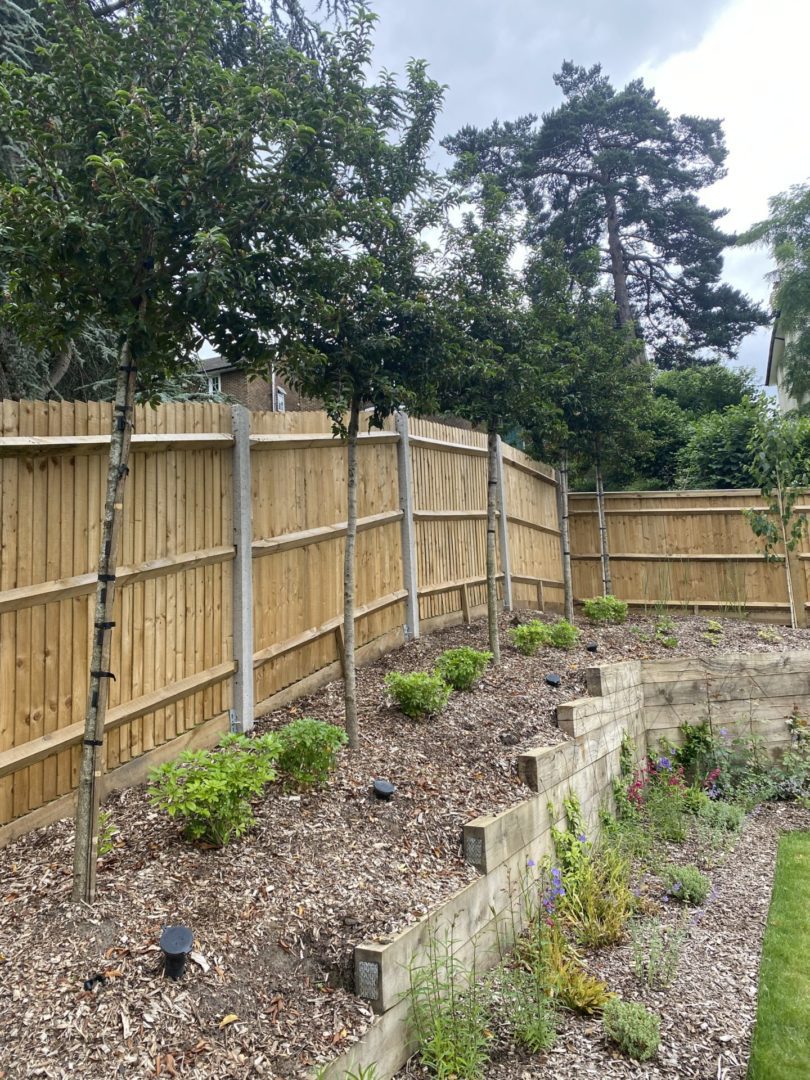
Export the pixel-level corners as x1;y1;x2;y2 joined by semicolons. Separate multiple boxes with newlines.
264;12;443;747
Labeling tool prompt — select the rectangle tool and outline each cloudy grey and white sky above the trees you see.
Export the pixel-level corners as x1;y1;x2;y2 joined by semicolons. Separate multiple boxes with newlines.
372;0;810;376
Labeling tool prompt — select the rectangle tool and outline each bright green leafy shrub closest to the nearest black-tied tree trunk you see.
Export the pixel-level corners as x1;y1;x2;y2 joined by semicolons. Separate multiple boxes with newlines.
149;733;279;848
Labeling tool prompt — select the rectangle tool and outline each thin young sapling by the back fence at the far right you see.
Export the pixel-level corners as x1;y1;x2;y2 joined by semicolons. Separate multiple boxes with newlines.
745;408;810;629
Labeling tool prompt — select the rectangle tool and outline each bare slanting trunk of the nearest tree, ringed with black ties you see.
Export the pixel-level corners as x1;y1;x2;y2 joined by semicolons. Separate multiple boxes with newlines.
73;319;139;904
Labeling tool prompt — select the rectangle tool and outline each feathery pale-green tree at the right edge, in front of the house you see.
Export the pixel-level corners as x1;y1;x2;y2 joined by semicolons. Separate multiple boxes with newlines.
739;183;810;403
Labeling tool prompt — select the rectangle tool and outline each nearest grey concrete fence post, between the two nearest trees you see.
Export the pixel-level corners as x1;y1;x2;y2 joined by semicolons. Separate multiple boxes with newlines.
230;405;254;731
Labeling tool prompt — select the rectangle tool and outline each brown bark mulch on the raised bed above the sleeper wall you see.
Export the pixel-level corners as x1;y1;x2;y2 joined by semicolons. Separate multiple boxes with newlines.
0;617;810;1080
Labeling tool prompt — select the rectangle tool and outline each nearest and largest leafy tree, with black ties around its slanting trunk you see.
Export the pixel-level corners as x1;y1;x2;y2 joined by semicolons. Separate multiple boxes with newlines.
0;0;354;901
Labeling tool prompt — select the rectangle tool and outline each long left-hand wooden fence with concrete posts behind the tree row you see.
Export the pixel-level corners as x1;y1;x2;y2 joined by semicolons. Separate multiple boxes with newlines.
0;402;562;829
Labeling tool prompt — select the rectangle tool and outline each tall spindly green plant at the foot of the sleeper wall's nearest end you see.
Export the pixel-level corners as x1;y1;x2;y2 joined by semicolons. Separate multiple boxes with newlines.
408;935;490;1080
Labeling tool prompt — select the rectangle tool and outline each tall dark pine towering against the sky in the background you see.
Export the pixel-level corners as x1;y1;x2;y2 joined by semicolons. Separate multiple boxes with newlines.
444;62;766;367
